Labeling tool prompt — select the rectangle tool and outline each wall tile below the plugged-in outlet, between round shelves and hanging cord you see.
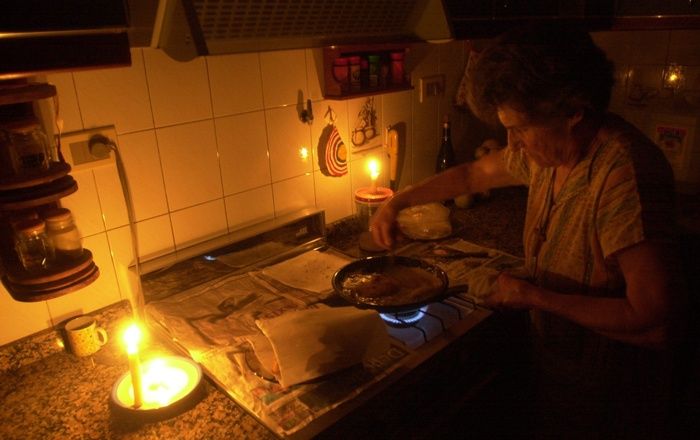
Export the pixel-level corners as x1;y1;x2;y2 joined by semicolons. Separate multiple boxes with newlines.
61;170;105;237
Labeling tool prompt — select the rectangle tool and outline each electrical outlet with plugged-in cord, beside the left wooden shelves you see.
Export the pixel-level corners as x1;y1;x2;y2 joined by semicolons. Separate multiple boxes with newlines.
61;126;117;170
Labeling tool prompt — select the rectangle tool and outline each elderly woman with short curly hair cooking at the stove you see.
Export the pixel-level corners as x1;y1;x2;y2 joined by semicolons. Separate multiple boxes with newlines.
370;26;683;438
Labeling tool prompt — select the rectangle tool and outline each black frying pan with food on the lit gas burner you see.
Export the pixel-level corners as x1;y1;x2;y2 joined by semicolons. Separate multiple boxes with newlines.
332;255;468;313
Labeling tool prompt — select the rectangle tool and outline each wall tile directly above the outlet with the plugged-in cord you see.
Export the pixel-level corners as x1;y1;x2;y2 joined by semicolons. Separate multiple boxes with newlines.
73;49;153;133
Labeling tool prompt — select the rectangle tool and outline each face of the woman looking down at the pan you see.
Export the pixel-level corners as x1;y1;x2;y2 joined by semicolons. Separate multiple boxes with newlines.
498;105;572;167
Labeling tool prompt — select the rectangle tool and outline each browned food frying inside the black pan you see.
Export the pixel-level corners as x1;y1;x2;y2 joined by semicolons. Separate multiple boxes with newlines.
342;265;444;306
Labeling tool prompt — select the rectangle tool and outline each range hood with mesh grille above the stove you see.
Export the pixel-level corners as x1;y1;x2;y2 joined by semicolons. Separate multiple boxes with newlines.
152;0;450;61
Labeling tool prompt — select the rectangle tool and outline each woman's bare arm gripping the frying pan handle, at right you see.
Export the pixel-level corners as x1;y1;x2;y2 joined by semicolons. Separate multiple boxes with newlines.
484;241;684;348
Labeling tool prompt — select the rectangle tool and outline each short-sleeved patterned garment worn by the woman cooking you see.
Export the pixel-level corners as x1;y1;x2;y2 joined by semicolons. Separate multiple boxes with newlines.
505;114;674;380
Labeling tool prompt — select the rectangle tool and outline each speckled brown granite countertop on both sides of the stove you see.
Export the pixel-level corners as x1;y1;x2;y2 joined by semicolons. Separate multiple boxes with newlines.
0;188;526;439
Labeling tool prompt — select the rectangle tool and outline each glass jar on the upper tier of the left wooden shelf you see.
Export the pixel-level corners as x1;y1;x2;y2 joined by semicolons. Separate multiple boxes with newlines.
0;117;51;175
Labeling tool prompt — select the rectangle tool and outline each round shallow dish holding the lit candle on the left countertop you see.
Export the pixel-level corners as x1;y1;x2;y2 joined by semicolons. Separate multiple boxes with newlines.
111;356;203;421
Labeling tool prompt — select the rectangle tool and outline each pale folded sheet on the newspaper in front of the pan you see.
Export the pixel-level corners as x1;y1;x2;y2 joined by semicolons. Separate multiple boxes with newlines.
251;307;389;388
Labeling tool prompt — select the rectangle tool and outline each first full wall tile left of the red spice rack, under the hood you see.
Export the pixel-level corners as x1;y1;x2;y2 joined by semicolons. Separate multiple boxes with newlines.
260;49;309;109
